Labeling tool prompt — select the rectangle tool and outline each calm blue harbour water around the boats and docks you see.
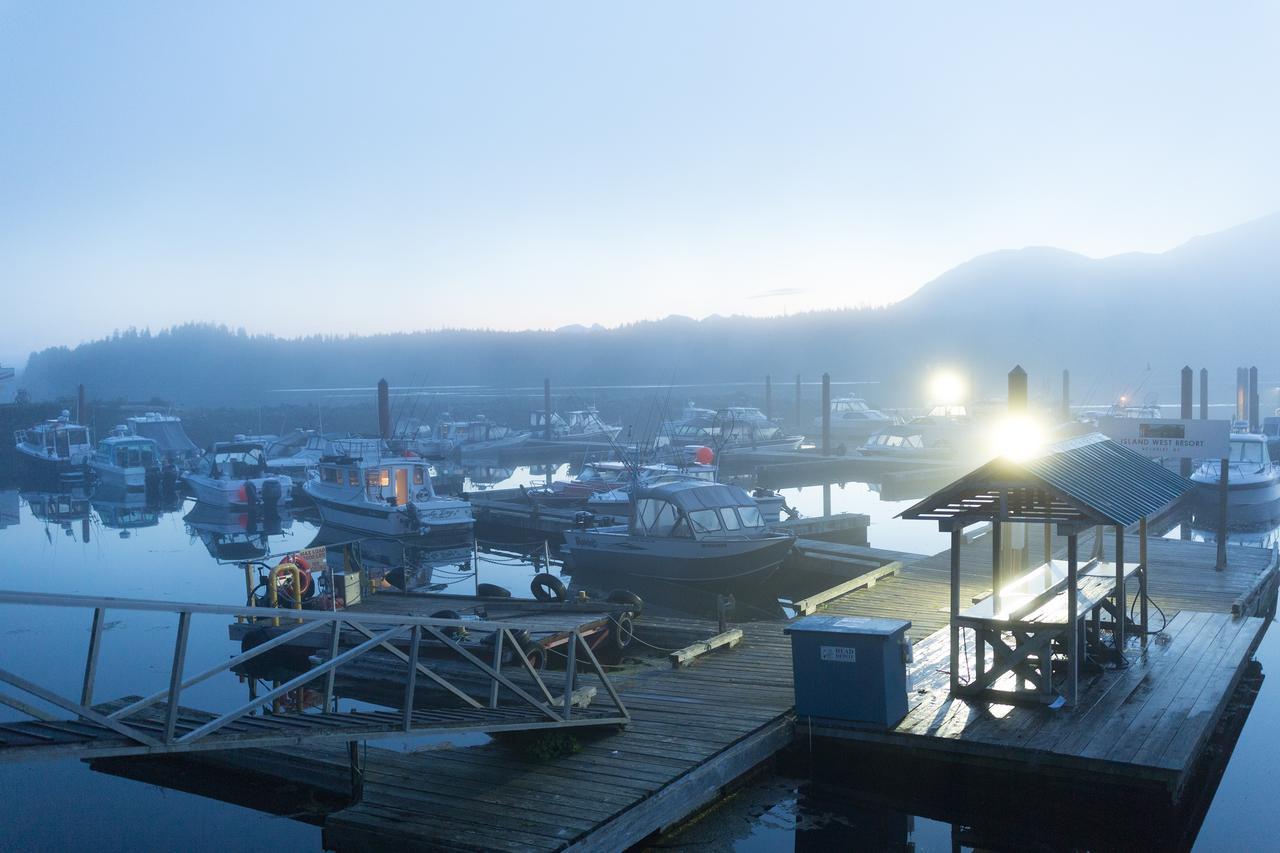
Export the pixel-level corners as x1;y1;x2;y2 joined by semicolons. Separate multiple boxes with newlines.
0;458;1280;850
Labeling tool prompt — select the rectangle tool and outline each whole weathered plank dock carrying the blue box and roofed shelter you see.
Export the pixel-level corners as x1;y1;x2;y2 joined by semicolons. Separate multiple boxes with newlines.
90;532;1276;852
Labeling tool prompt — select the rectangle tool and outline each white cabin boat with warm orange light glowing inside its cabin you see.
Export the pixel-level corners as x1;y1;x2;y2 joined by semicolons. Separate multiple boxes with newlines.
302;455;475;538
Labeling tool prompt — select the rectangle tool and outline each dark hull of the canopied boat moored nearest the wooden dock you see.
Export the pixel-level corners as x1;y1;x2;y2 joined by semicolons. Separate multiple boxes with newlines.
563;530;795;585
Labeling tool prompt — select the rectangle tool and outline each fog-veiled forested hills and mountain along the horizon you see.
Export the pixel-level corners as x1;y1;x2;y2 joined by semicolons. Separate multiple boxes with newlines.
20;214;1280;405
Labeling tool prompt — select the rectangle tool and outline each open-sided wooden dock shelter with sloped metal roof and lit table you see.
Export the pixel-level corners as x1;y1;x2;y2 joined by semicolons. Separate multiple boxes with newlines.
900;434;1192;706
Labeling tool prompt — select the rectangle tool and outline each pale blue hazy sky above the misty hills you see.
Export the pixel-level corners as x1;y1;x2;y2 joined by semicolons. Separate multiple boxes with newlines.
0;0;1280;366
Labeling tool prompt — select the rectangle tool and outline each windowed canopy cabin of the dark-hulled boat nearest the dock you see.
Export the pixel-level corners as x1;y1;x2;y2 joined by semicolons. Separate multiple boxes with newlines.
631;480;764;539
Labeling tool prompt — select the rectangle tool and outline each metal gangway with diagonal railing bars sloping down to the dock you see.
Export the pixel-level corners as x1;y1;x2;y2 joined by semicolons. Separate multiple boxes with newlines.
0;592;630;762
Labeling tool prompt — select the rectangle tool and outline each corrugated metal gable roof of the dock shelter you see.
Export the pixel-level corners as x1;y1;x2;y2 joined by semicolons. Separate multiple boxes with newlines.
899;433;1192;530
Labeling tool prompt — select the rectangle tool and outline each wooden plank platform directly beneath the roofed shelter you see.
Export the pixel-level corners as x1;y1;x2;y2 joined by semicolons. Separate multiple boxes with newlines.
800;611;1267;797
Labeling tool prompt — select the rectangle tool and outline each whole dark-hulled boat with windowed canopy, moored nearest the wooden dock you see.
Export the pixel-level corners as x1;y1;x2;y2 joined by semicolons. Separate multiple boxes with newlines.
562;480;795;585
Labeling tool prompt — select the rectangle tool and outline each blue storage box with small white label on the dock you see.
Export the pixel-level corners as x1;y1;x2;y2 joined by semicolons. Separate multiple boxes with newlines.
783;616;911;729
